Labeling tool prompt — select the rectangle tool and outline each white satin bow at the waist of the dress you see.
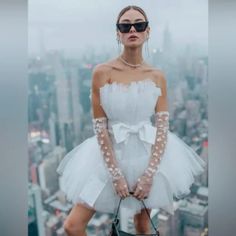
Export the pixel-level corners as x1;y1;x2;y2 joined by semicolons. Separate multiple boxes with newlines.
111;121;157;144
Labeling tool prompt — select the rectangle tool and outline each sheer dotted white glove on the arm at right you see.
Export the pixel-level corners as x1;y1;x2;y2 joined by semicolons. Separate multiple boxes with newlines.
134;111;169;199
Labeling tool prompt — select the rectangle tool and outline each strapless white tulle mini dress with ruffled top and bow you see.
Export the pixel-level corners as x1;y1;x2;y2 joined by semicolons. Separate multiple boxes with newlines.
57;79;206;214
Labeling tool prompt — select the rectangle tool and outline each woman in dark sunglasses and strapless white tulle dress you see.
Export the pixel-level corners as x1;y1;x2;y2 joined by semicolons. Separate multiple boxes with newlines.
58;6;205;236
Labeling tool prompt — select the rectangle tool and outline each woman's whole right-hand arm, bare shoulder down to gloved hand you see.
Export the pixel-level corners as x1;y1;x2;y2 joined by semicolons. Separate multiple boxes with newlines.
134;71;169;199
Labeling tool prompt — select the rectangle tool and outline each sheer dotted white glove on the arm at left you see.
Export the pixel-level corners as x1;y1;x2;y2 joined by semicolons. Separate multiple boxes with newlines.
92;117;129;198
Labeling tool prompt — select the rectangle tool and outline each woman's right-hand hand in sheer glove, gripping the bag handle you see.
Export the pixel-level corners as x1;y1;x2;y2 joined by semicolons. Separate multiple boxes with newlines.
133;174;153;200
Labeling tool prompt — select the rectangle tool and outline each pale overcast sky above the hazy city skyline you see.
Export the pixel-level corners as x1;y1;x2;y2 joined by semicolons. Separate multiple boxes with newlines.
28;0;208;56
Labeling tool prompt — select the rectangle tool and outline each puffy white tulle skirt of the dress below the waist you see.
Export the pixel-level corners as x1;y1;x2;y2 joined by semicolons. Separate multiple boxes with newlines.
57;131;206;214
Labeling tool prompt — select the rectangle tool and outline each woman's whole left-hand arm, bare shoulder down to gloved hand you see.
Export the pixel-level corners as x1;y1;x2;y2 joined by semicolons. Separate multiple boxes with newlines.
92;65;129;197
